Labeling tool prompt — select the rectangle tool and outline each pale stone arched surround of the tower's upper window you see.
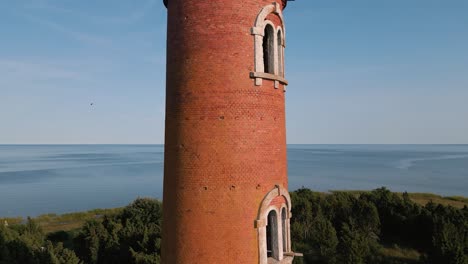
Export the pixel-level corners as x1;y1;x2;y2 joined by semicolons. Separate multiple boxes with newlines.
250;2;287;88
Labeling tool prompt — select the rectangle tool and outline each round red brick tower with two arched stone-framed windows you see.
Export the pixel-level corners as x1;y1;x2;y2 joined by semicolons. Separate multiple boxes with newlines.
162;0;293;264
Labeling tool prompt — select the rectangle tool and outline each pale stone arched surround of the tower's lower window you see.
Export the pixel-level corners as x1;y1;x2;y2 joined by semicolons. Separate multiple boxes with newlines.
255;185;291;264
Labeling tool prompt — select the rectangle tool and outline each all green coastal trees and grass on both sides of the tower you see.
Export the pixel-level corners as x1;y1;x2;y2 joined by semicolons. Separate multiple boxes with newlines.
0;188;468;264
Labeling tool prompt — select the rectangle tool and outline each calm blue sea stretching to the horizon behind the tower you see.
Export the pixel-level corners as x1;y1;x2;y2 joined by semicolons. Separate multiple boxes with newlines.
0;145;468;216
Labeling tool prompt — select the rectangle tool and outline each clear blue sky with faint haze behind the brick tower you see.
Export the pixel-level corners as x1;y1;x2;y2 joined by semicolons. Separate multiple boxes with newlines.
0;0;468;144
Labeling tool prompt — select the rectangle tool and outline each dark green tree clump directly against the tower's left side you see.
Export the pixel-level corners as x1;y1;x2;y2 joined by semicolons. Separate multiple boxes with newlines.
74;199;162;264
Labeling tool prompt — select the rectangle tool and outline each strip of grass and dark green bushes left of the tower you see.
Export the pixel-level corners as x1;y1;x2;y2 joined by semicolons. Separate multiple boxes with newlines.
0;198;162;264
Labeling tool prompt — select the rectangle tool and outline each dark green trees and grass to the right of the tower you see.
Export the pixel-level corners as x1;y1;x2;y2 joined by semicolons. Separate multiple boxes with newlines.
291;188;468;264
